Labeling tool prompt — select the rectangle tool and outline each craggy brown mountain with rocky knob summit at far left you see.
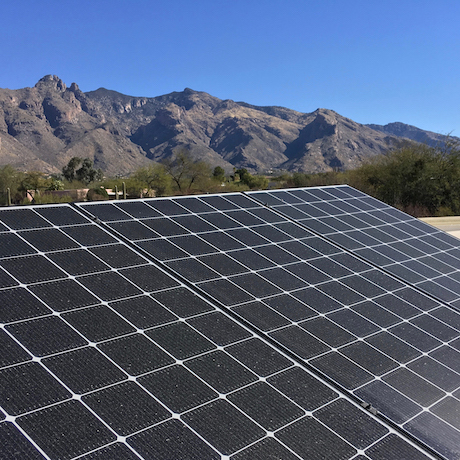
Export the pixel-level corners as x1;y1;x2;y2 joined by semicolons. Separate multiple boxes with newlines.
0;75;146;174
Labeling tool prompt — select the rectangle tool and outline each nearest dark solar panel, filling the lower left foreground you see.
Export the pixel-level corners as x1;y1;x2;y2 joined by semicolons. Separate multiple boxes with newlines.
0;202;432;460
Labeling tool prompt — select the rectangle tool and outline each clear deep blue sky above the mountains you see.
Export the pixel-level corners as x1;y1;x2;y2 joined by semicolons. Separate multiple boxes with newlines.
0;0;460;136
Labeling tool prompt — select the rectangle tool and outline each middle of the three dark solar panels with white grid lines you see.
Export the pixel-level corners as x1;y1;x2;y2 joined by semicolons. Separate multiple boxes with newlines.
74;192;460;458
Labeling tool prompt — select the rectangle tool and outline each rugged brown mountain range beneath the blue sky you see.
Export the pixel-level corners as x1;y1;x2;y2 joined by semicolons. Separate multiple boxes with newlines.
0;75;452;176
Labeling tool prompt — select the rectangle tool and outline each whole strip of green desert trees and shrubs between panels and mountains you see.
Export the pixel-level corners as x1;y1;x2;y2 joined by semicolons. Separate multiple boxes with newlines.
0;139;460;217
